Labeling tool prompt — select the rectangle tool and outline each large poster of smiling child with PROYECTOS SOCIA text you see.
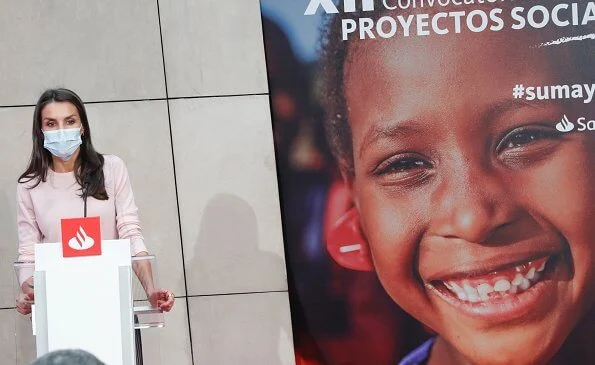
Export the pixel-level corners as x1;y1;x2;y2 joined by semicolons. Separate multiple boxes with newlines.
261;0;595;365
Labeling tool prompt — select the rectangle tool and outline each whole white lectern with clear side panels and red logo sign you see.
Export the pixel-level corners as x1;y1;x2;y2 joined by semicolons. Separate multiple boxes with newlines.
15;217;164;365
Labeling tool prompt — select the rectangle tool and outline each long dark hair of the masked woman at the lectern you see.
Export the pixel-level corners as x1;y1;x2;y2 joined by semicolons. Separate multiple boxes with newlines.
18;89;108;200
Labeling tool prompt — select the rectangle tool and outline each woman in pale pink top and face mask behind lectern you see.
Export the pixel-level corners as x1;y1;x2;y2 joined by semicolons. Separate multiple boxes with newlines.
16;89;175;314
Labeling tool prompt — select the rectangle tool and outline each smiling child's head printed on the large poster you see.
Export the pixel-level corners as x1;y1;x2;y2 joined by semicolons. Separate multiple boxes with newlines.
324;1;595;365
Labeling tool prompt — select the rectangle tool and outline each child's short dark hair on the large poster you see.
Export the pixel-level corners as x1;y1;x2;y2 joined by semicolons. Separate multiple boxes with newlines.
321;0;595;174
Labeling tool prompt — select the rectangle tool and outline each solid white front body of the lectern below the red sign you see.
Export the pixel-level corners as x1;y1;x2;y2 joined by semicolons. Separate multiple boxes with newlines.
32;240;135;365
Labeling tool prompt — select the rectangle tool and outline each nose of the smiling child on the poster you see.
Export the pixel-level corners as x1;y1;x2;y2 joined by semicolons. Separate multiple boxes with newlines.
431;168;521;243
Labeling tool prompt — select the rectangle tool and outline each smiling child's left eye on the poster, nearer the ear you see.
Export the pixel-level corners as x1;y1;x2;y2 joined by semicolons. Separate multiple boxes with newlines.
374;155;432;182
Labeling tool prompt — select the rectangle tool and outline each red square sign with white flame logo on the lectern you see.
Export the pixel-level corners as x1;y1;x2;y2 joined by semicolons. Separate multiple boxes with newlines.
62;217;101;257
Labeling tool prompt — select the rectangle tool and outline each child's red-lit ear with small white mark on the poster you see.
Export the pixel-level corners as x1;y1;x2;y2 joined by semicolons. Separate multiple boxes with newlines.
326;208;374;271
